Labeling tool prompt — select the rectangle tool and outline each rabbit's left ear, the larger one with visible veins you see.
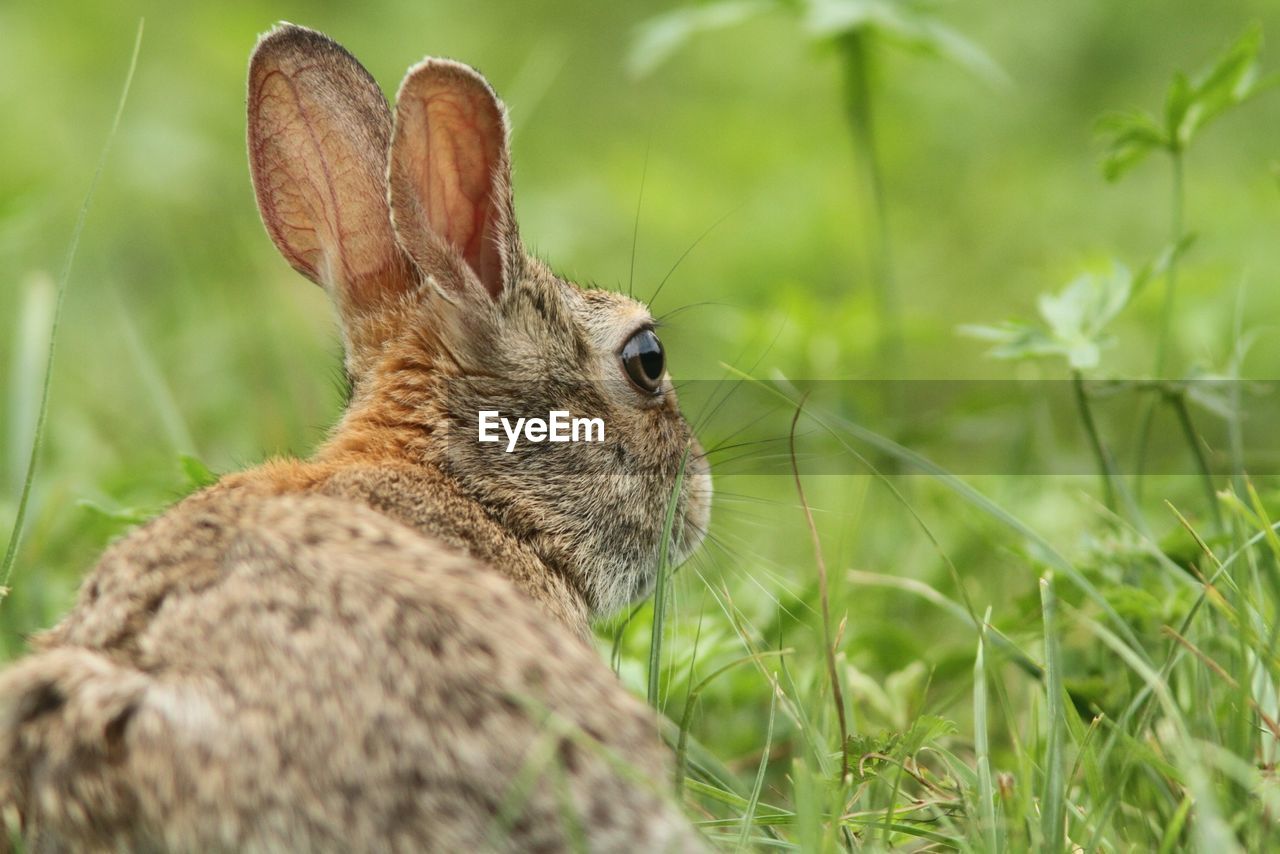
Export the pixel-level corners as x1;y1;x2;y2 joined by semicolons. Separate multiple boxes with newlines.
248;24;416;317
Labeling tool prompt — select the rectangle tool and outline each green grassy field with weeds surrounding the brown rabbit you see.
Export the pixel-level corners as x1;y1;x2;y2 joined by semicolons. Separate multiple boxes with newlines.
0;0;1280;854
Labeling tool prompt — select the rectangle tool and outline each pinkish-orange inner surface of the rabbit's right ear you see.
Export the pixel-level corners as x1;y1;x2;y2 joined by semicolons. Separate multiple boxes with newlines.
396;74;506;298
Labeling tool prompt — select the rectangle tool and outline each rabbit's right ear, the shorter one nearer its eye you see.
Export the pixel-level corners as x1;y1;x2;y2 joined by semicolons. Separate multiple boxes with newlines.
388;59;521;300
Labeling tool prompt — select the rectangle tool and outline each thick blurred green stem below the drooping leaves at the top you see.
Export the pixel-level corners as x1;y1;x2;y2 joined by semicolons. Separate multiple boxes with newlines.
838;31;902;364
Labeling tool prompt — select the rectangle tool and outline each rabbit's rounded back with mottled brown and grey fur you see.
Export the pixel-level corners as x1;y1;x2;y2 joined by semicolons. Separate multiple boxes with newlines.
0;492;696;850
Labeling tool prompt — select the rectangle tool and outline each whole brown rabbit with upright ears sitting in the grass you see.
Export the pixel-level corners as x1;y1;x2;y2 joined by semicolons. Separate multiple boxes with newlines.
0;24;712;851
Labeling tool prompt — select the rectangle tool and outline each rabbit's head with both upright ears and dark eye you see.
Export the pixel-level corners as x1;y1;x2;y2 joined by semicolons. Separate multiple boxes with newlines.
248;26;710;615
